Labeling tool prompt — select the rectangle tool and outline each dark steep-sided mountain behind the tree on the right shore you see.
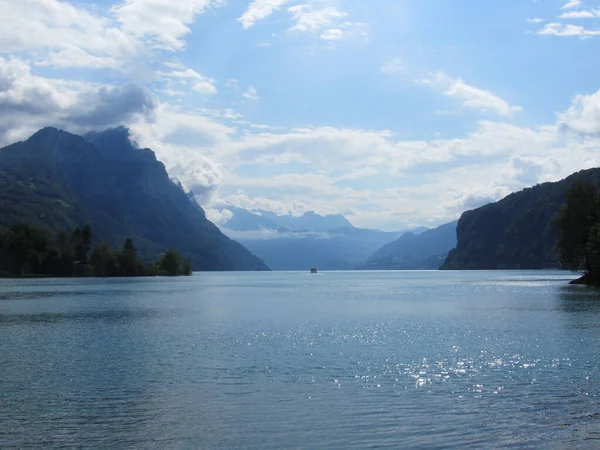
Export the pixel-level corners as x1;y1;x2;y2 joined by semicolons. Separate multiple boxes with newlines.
442;169;600;270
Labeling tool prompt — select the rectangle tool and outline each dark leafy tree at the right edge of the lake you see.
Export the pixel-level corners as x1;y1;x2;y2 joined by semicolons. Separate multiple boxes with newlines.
554;180;600;279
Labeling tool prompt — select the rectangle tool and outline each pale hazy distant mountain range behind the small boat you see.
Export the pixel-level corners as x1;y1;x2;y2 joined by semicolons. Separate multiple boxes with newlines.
212;205;422;270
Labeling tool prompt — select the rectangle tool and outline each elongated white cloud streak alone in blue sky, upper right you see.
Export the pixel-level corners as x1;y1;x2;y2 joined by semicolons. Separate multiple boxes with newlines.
417;72;522;117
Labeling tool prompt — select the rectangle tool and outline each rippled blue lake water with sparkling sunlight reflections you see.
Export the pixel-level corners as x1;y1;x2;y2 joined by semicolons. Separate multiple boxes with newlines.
0;271;600;449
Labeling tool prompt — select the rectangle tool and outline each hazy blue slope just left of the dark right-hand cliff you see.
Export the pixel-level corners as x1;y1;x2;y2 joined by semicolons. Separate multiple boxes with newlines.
361;221;457;270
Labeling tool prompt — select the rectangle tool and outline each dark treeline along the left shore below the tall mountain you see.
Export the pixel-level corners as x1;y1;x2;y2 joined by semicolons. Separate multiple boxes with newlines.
0;224;192;277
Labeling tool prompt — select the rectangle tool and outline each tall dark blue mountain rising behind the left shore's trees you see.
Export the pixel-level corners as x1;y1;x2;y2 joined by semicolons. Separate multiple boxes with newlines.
0;128;268;270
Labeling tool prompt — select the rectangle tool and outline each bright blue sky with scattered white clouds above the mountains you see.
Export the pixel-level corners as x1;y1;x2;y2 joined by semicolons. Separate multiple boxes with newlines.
0;0;600;230
